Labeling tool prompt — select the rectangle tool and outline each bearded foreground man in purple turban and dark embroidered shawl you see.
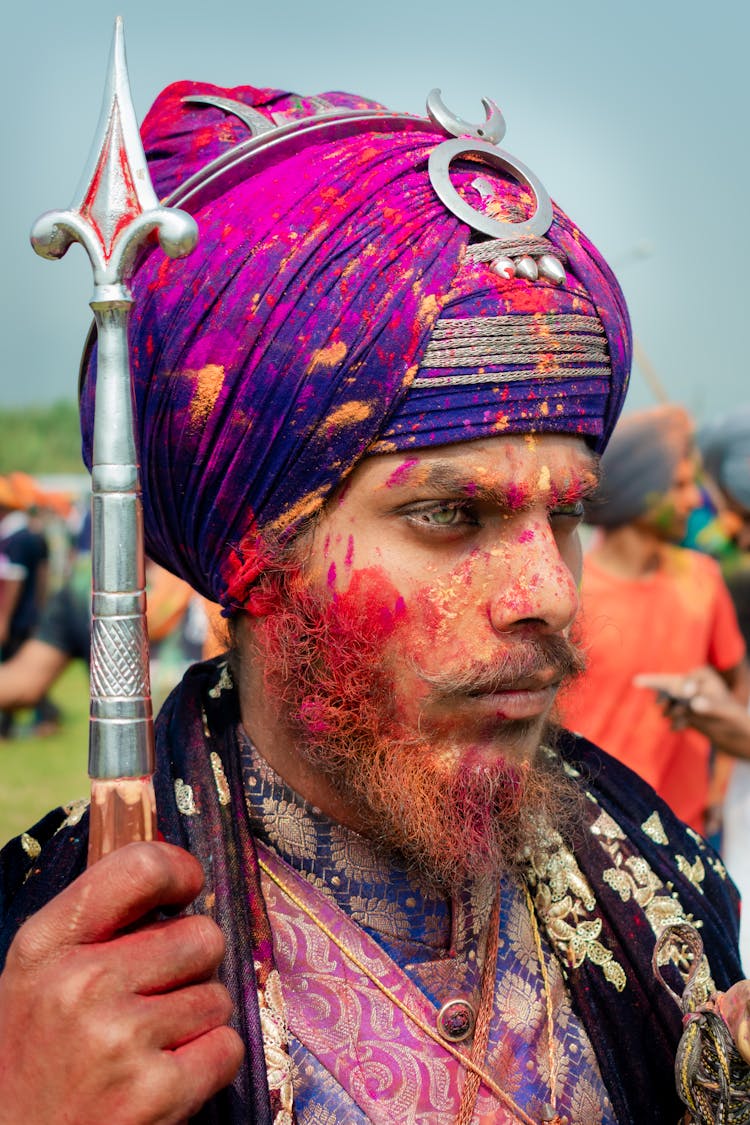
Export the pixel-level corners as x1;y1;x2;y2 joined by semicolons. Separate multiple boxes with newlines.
0;82;747;1125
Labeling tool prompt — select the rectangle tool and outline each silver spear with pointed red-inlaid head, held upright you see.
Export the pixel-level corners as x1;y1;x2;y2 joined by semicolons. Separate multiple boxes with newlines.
31;17;198;864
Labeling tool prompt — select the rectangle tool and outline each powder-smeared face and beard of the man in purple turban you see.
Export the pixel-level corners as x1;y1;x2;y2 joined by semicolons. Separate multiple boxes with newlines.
251;437;596;885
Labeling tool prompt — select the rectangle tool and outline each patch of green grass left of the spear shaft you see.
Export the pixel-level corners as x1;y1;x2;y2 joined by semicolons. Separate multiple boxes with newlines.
0;660;89;845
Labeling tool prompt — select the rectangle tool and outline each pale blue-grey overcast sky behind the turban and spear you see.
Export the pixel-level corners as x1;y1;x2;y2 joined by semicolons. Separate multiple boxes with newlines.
0;0;750;417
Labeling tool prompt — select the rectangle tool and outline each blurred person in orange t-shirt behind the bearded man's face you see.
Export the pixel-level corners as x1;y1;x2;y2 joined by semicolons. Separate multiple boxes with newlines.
561;406;749;833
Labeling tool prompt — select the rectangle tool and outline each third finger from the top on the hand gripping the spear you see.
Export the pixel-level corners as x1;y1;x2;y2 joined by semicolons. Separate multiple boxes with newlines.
138;981;233;1050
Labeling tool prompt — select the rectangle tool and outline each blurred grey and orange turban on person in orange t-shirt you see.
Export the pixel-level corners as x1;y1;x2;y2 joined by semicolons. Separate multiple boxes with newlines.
586;405;693;528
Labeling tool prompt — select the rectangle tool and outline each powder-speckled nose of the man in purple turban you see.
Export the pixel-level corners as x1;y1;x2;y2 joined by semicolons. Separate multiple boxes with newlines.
489;521;579;633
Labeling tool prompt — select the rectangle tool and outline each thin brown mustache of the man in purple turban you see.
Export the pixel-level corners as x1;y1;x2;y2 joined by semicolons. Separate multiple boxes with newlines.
416;633;586;696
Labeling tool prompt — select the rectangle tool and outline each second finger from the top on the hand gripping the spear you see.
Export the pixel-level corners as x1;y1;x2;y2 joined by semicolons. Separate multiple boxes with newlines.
106;915;226;995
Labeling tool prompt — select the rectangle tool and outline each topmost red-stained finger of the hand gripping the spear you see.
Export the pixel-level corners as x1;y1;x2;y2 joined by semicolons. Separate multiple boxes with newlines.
15;843;204;961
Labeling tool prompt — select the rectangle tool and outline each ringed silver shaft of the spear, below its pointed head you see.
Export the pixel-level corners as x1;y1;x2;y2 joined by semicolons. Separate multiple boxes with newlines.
89;295;155;864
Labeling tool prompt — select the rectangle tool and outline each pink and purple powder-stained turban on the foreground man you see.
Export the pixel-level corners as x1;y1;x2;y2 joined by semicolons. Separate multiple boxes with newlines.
82;82;631;609
